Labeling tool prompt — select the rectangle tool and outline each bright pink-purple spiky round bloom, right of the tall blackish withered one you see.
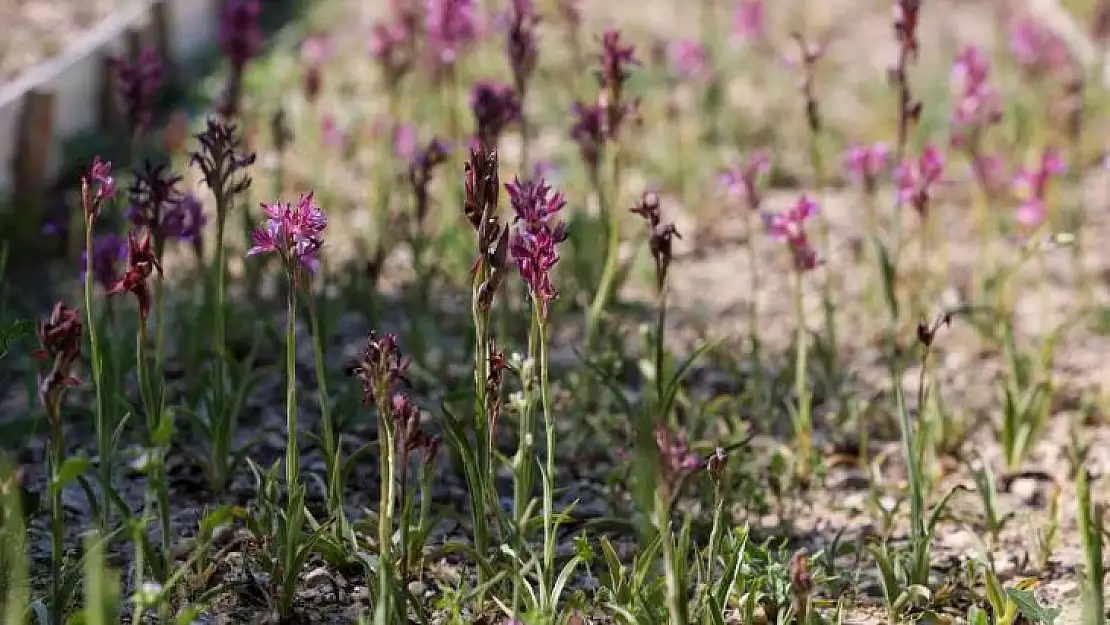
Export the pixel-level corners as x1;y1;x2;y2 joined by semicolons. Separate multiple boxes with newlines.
246;192;327;273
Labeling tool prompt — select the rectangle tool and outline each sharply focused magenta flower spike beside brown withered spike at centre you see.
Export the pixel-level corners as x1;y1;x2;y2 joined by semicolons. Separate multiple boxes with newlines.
505;179;566;320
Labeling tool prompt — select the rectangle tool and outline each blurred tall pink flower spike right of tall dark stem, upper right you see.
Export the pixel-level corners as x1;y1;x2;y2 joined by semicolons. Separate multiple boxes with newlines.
951;46;1002;149
